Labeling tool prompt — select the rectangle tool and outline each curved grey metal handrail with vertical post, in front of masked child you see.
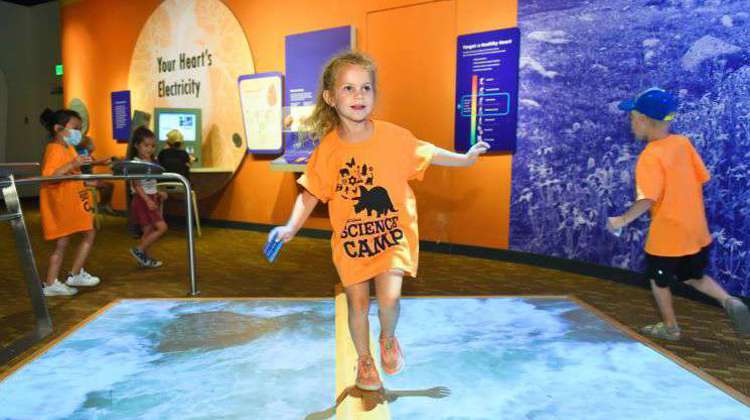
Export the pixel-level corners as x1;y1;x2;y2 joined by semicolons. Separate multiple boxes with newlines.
15;172;200;296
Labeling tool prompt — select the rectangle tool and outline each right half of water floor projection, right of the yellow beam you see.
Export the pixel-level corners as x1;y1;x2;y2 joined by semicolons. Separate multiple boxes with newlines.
362;298;750;420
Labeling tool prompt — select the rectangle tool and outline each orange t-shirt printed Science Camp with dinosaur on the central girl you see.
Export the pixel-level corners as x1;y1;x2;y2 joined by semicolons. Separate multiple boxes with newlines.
298;121;435;286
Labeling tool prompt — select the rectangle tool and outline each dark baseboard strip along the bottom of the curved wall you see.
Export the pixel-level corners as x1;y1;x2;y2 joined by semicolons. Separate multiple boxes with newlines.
198;218;728;306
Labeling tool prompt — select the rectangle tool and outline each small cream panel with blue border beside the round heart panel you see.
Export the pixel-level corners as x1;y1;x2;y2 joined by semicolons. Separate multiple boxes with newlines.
237;72;284;154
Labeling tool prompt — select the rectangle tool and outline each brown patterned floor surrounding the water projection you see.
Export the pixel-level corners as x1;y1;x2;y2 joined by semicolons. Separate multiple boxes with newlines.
0;210;750;396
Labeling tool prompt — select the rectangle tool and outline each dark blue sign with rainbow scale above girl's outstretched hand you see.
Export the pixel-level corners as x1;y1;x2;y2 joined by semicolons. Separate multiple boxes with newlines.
455;28;520;153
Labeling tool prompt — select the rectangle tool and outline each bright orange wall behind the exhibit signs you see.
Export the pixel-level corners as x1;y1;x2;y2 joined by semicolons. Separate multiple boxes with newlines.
61;0;517;248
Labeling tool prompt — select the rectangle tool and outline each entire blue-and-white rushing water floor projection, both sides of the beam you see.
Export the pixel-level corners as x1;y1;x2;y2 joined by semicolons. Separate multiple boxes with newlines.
0;295;750;419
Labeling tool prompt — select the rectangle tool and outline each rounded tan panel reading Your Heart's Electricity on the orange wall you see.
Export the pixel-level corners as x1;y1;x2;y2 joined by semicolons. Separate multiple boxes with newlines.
128;0;255;174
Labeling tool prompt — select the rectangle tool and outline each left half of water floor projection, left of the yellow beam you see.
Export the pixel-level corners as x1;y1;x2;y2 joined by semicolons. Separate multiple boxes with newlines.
0;299;335;419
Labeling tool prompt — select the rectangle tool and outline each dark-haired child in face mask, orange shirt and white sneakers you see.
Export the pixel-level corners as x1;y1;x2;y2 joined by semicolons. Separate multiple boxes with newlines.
39;108;99;296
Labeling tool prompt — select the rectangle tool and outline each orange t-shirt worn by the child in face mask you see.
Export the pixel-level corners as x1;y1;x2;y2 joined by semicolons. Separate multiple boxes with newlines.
39;142;94;241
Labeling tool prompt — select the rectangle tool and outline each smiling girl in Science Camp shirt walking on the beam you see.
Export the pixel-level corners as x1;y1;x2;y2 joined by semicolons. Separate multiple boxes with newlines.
270;52;489;390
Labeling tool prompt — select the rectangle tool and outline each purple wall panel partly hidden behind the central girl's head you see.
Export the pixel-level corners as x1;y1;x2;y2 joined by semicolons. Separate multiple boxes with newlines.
284;26;354;164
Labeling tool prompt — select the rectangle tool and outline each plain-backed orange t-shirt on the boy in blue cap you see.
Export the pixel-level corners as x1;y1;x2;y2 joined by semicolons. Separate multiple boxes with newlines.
635;134;711;257
